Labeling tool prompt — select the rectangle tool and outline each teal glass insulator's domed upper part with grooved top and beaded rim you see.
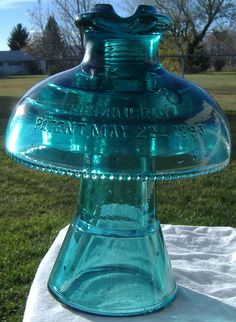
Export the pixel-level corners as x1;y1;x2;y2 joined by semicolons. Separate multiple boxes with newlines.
6;5;230;180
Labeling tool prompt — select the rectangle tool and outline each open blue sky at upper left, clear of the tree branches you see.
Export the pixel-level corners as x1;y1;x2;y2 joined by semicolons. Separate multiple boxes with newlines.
0;0;127;51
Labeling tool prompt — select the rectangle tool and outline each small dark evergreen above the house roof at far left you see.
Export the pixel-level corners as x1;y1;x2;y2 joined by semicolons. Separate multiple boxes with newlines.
8;23;29;50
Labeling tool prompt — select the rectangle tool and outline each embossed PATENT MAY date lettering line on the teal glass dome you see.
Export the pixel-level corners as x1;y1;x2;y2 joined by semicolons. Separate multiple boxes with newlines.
35;117;204;140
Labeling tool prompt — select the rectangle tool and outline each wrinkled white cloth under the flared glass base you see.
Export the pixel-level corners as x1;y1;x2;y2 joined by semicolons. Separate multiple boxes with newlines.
23;225;236;322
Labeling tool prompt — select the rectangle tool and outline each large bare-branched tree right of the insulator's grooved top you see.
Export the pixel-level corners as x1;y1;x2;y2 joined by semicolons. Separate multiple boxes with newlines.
127;0;236;55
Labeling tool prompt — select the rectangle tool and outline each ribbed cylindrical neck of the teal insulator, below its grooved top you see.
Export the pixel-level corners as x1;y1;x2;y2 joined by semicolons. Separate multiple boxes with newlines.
83;33;161;71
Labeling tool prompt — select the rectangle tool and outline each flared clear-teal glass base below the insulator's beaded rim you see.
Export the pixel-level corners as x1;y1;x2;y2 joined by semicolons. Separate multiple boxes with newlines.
48;179;176;316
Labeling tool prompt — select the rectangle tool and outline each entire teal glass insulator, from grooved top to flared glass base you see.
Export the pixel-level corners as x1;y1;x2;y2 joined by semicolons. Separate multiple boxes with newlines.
6;4;231;316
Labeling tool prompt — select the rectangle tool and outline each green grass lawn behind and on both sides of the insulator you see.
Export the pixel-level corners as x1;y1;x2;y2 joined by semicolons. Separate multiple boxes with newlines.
0;73;236;322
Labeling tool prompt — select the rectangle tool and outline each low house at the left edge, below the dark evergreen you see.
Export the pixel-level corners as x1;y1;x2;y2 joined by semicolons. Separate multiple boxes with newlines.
0;50;47;75
